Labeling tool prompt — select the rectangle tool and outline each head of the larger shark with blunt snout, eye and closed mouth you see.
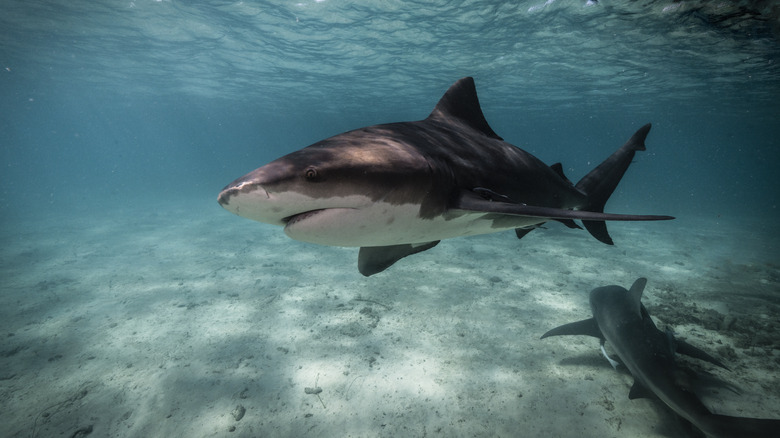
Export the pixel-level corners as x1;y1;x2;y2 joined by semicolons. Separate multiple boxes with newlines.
218;125;432;246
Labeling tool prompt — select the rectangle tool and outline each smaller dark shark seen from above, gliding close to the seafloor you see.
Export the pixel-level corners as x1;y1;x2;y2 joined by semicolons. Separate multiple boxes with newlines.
542;278;780;438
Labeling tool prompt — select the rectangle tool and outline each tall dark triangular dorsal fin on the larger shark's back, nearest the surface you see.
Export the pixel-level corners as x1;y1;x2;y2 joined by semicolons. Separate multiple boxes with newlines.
428;77;503;140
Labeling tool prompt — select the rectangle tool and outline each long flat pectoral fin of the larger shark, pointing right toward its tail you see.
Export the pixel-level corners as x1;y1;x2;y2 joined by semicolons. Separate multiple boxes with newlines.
453;188;674;221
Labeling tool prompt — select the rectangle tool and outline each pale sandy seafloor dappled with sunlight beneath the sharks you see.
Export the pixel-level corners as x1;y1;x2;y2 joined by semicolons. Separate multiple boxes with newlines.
0;199;780;437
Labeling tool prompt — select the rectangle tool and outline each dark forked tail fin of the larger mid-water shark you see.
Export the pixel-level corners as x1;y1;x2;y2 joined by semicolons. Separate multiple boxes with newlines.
576;123;651;245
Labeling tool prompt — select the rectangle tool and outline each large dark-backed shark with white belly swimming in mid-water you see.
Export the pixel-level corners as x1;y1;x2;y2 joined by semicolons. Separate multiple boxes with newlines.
218;77;673;276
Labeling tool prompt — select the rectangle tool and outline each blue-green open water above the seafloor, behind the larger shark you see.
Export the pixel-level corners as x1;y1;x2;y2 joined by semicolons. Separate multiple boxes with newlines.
0;0;780;222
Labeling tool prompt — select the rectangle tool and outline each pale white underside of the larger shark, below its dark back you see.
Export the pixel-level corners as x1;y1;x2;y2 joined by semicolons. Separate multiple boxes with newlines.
284;202;544;247
